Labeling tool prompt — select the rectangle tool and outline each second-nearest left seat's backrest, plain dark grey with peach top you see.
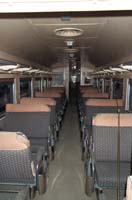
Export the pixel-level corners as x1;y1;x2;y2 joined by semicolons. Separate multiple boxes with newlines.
5;104;51;144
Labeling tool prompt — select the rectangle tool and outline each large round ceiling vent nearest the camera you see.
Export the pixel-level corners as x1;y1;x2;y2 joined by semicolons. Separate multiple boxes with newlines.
54;28;83;37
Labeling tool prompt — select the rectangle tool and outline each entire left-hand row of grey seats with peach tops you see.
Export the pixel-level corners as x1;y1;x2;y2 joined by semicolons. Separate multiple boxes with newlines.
0;88;66;199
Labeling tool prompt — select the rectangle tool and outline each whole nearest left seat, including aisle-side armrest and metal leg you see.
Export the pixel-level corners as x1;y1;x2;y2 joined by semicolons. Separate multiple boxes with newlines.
0;131;47;200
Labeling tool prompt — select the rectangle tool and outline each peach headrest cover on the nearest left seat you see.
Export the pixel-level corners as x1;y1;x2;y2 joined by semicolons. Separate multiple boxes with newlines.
0;131;30;150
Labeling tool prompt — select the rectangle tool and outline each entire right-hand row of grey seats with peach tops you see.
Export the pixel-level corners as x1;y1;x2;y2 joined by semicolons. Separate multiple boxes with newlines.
78;87;132;199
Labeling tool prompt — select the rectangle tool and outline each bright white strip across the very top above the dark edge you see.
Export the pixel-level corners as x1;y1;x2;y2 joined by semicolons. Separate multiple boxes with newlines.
0;0;132;13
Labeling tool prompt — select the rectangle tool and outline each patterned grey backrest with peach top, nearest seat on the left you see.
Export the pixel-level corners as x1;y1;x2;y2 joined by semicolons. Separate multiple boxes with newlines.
0;131;36;185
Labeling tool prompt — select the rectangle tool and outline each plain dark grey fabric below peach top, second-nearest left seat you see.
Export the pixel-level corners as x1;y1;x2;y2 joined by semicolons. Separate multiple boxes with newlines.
5;112;50;146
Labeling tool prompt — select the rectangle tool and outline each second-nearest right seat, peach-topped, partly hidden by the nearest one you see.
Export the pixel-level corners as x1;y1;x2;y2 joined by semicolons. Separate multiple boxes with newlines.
81;99;124;162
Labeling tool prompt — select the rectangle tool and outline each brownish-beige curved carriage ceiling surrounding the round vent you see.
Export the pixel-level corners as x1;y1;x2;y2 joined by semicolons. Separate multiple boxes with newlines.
0;13;132;67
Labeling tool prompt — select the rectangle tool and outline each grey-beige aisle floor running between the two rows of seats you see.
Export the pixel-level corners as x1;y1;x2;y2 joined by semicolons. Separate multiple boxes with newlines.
34;105;89;200
